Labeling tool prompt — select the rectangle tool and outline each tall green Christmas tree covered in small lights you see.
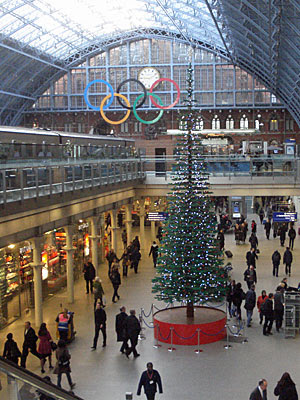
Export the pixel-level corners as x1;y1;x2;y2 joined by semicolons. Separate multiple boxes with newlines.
153;65;227;318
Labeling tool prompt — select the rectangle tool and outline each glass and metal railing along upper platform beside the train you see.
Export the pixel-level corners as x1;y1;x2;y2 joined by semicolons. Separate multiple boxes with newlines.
0;158;145;205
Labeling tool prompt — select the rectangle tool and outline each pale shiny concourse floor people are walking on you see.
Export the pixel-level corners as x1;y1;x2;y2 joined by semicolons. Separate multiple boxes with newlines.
0;218;300;400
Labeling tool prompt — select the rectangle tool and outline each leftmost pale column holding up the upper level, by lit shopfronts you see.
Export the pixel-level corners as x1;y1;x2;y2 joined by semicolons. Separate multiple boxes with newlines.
31;236;43;328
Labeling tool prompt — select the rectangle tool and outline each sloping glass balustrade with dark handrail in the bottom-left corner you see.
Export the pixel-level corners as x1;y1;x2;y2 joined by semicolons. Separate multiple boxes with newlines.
0;357;83;400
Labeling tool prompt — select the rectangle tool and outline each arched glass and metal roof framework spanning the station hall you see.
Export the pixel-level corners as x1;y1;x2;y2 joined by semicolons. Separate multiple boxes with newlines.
0;0;300;124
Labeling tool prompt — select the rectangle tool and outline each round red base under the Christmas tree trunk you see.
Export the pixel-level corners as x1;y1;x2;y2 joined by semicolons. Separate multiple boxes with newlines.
153;306;226;346
